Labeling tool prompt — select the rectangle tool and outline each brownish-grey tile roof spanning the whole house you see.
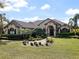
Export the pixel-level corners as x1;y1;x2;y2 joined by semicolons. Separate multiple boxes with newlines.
4;18;65;28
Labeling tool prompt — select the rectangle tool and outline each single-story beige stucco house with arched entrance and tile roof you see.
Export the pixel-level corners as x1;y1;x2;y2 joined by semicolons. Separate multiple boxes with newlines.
4;18;70;37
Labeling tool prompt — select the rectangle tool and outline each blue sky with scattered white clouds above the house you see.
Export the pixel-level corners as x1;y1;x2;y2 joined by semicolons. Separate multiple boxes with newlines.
0;0;79;23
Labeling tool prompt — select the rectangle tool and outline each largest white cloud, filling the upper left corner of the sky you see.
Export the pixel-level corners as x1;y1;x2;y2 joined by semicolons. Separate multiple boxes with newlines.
0;0;28;12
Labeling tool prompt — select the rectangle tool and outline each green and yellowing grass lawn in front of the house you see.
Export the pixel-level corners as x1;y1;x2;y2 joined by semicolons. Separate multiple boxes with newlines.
0;38;79;59
